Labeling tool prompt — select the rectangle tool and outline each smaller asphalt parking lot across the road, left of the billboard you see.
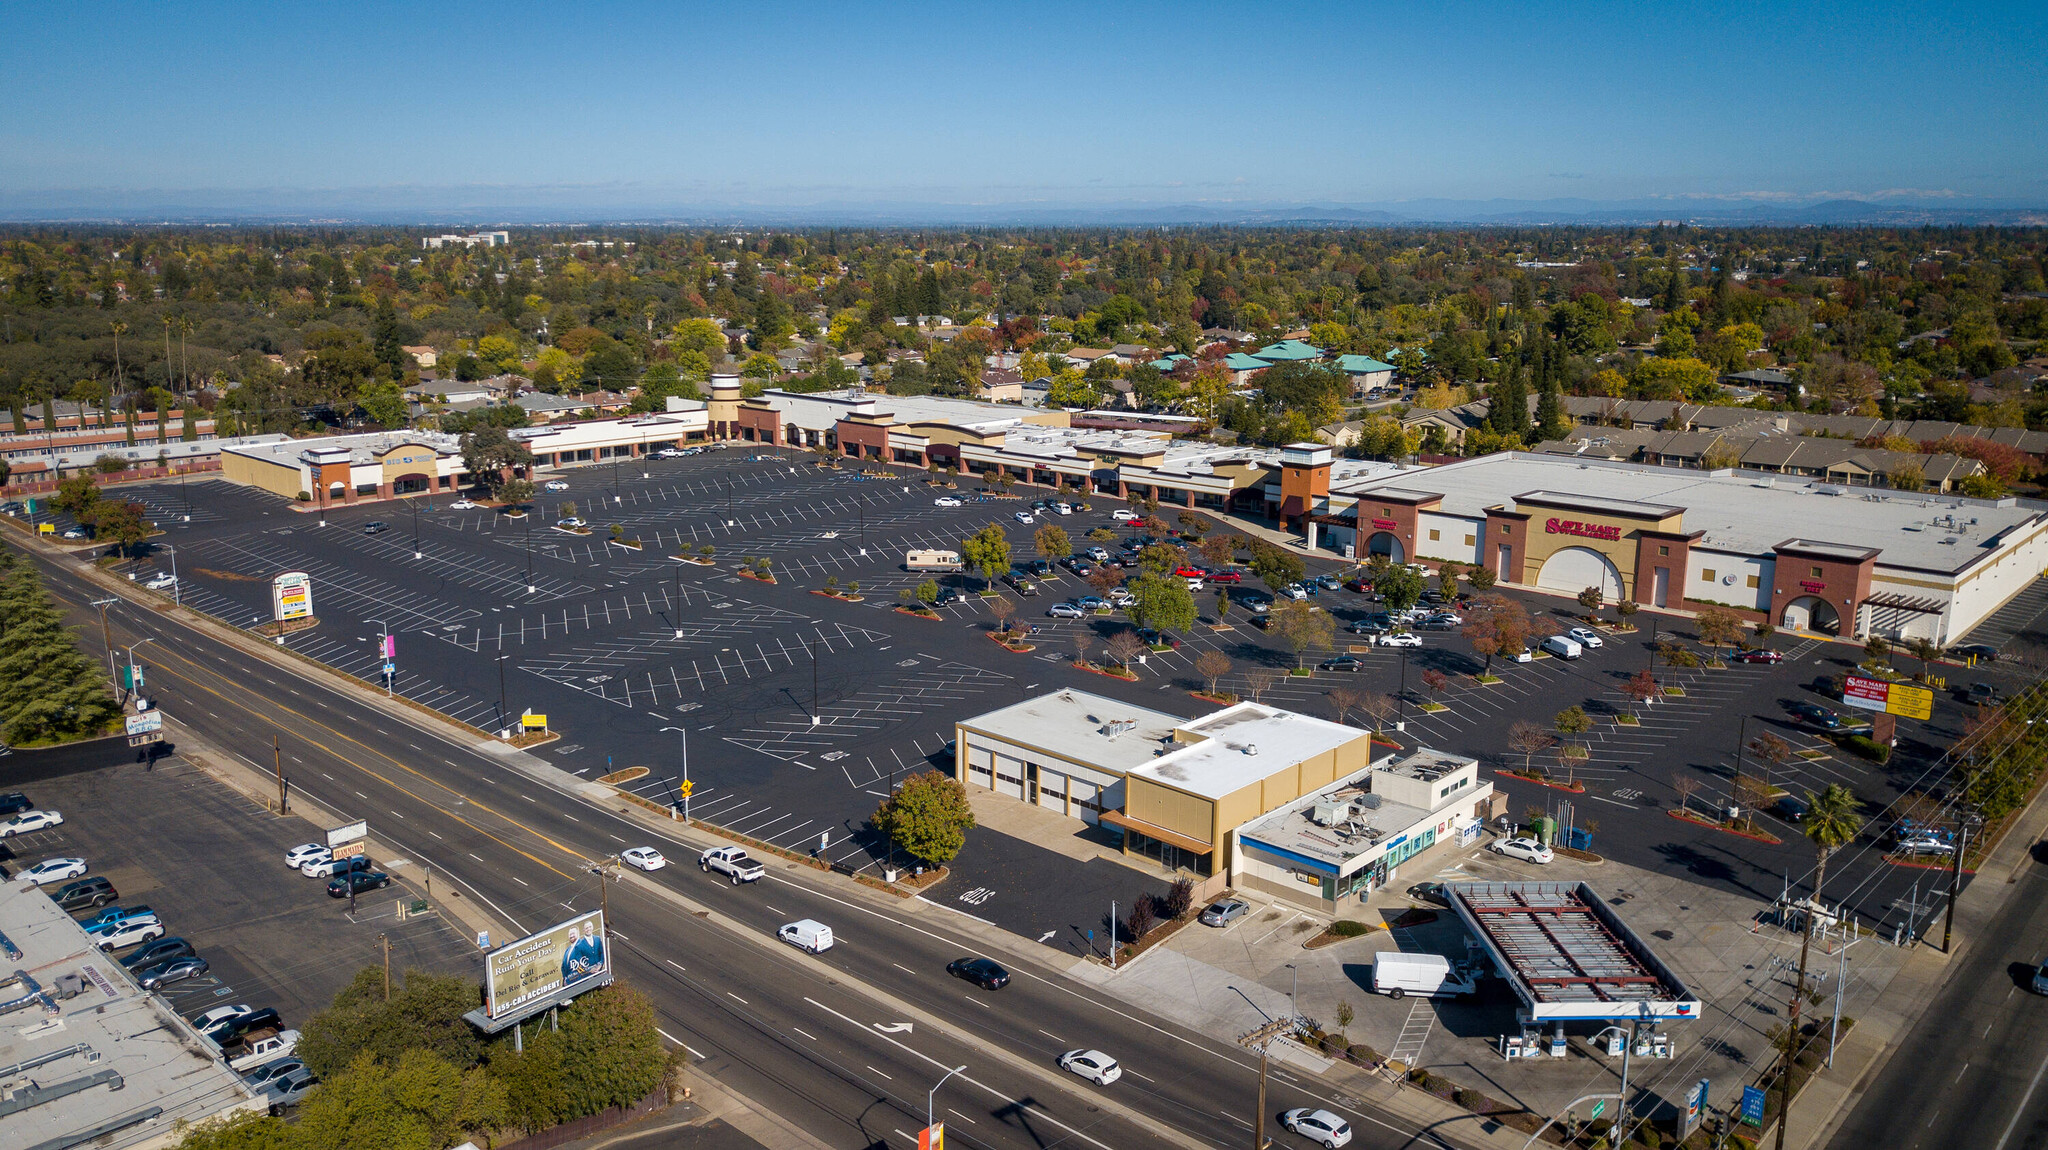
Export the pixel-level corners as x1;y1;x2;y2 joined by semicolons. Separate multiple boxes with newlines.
0;755;477;1025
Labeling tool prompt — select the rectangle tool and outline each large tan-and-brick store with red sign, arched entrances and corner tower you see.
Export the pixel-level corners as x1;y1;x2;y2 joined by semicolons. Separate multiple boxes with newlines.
1278;444;2048;643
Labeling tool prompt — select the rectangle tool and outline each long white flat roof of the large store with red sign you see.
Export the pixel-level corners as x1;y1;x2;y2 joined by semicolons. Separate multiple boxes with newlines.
1350;452;2042;573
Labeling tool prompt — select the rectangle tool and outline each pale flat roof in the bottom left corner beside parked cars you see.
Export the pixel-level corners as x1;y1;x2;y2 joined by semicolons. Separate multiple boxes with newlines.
0;882;256;1150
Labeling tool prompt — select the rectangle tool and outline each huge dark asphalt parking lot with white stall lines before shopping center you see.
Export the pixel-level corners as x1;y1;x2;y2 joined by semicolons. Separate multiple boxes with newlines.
99;448;2048;937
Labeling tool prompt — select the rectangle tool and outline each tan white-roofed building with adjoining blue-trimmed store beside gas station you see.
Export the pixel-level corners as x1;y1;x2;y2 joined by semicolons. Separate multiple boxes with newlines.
954;690;1493;911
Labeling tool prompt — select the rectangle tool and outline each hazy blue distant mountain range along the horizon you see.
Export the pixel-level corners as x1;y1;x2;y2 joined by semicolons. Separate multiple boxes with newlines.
0;186;2048;227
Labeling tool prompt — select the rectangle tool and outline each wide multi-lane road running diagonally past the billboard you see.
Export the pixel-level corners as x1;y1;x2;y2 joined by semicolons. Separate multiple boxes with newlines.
39;536;1474;1148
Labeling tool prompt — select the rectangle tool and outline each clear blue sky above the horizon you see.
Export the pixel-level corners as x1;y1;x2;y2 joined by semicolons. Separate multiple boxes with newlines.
0;0;2048;207
